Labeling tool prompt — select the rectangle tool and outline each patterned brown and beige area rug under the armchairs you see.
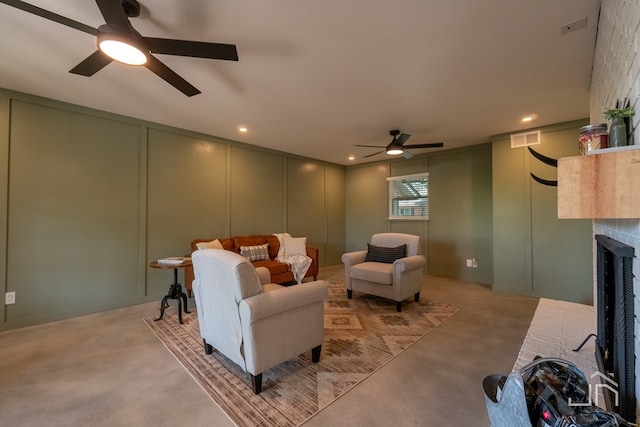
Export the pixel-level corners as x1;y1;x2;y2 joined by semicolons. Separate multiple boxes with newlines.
145;281;460;426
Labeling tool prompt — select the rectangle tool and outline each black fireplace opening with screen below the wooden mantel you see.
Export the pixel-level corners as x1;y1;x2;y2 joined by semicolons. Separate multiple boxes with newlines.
595;234;636;422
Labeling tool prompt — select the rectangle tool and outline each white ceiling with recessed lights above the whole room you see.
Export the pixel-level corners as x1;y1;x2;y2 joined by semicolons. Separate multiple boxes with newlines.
0;0;600;165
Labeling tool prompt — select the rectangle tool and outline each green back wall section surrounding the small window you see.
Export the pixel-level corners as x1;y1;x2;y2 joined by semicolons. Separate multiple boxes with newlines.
346;144;493;284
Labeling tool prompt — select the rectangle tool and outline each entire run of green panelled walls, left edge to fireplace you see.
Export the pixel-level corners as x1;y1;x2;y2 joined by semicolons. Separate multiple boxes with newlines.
0;89;592;330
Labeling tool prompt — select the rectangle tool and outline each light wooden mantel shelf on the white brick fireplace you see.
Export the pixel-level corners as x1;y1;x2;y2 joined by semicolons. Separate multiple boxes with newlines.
558;146;640;219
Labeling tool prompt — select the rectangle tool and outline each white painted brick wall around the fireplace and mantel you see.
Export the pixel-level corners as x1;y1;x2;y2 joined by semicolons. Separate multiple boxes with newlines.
589;0;640;420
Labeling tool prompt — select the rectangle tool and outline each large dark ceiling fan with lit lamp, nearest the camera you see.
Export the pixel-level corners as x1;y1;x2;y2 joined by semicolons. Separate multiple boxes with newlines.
0;0;238;96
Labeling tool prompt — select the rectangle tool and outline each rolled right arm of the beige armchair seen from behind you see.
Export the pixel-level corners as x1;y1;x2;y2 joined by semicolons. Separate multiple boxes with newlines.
239;280;329;324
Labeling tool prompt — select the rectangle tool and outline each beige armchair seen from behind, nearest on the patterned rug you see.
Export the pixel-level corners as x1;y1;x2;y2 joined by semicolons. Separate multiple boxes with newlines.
191;249;328;394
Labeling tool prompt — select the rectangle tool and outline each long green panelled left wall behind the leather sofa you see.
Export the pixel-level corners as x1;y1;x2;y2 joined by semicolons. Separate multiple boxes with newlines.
0;90;346;330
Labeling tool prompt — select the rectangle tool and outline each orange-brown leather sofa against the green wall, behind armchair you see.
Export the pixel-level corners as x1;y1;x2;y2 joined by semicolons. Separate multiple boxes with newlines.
184;234;319;295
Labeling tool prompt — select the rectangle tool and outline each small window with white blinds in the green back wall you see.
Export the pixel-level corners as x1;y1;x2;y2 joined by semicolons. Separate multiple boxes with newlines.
387;173;429;220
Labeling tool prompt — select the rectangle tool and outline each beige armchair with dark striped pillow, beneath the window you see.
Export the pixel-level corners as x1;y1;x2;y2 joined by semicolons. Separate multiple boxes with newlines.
342;233;426;311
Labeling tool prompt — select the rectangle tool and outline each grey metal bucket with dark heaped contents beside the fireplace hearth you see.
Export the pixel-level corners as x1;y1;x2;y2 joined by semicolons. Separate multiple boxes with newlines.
483;358;630;427
